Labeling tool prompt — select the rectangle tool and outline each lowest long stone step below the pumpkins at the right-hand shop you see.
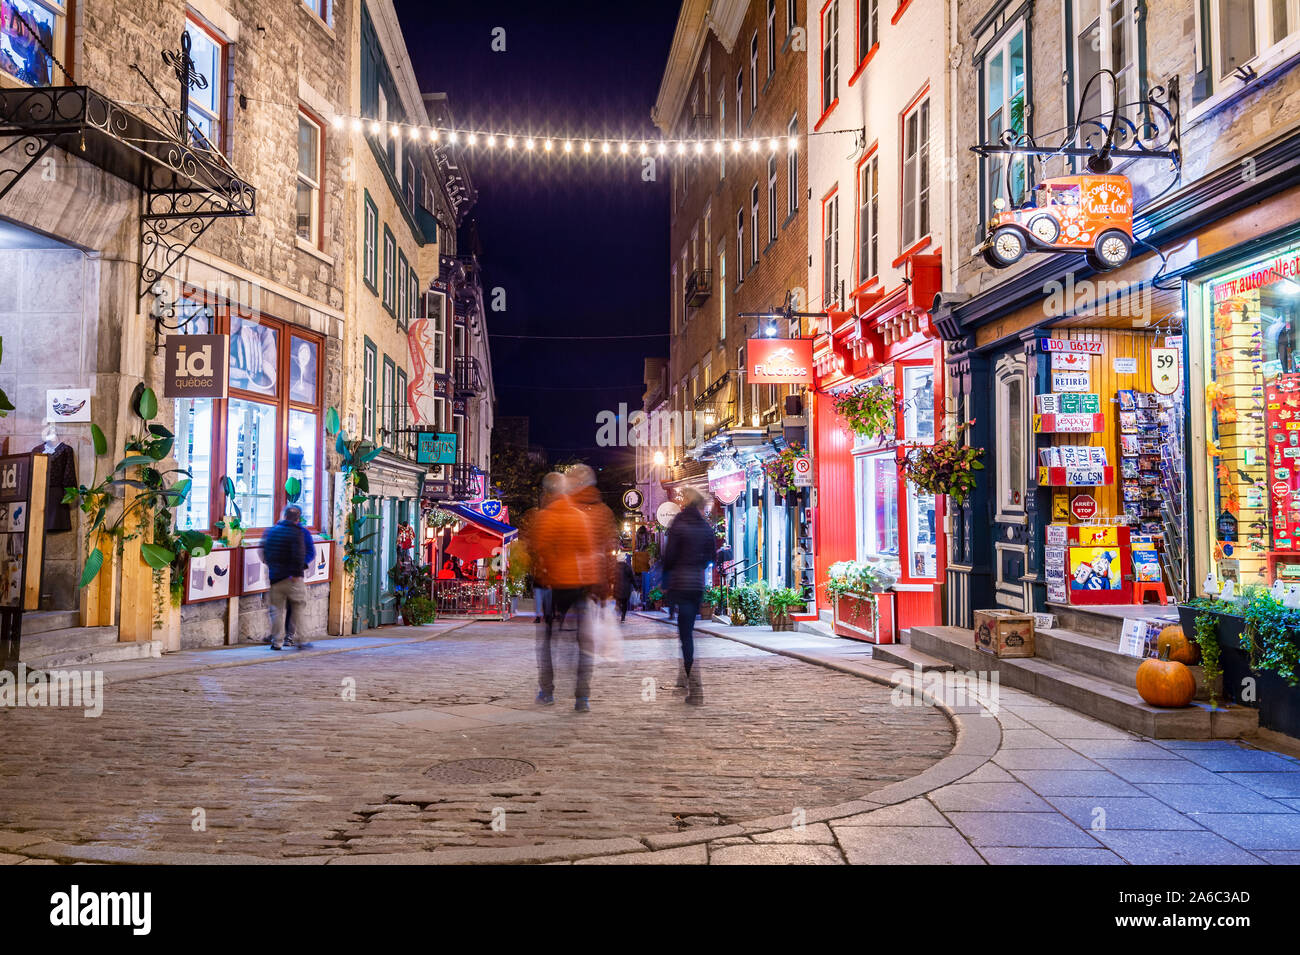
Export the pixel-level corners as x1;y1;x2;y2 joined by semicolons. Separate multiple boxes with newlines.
911;626;1260;739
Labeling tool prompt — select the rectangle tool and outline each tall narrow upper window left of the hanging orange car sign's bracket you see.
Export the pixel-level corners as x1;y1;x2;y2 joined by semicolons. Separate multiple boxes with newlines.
980;23;1024;214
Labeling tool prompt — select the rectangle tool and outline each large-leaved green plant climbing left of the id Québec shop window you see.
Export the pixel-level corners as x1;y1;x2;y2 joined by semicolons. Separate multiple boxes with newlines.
62;386;212;603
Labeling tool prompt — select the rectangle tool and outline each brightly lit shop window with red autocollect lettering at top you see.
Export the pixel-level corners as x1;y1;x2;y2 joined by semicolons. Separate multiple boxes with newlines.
1201;248;1300;591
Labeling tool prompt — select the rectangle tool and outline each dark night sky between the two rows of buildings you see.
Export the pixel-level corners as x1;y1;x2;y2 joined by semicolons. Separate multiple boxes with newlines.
395;0;677;464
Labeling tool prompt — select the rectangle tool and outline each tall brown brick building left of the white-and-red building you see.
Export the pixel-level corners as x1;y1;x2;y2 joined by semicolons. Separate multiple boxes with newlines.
651;0;810;597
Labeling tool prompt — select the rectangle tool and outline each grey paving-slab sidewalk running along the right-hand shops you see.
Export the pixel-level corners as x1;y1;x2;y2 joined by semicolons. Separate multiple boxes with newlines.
621;613;1300;865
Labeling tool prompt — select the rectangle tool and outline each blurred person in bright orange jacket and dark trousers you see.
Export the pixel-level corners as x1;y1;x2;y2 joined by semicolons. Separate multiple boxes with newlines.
533;465;615;712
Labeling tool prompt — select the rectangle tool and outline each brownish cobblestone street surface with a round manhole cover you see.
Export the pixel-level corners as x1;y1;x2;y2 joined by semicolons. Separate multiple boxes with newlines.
0;616;954;861
